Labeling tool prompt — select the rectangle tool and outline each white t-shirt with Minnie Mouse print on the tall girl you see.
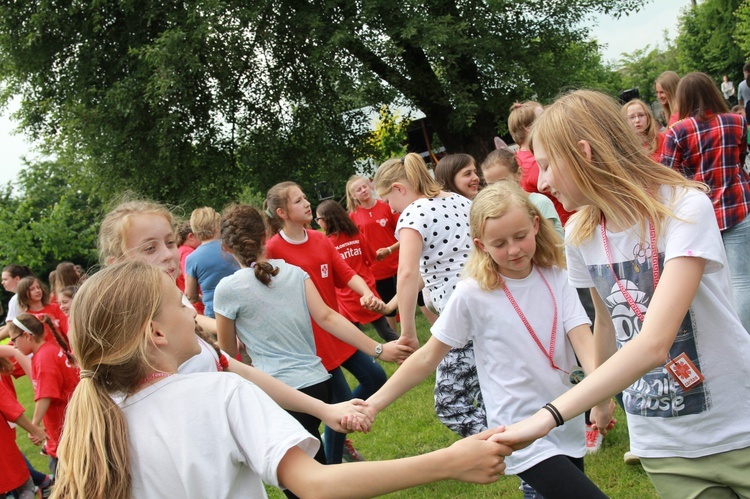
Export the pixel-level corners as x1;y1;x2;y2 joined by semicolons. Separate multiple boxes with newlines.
567;187;750;458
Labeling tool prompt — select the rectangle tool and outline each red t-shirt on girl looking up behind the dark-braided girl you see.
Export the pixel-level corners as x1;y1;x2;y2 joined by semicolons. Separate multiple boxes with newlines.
266;229;357;371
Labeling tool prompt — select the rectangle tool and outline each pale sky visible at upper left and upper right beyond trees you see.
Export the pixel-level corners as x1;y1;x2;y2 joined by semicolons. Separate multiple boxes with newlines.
0;0;690;185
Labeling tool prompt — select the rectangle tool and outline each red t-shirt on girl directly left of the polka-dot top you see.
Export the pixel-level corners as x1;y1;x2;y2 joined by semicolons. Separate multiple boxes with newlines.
349;199;398;281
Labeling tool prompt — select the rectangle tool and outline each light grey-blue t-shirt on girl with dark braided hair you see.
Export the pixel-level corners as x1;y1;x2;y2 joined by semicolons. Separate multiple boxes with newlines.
214;260;330;389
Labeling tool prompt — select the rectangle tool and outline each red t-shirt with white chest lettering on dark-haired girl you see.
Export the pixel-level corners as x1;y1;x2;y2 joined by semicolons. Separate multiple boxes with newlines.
328;234;380;324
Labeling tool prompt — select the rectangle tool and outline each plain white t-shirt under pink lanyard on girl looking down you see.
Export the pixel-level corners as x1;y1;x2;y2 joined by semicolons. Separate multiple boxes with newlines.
432;268;590;474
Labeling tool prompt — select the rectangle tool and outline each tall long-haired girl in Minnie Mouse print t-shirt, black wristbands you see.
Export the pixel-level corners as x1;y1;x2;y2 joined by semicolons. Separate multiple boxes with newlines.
498;90;750;498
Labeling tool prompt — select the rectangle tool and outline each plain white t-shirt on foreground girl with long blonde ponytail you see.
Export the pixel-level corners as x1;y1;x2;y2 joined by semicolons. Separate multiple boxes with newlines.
120;373;319;499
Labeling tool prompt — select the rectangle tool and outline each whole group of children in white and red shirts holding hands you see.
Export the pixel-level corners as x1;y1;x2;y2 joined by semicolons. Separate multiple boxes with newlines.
0;83;750;498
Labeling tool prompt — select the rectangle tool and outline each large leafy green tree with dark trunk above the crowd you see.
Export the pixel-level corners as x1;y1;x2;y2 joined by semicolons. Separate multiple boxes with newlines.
0;0;643;206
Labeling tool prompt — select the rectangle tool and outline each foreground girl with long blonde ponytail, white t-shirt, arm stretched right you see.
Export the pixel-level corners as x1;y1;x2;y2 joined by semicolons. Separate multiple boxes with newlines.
53;261;509;499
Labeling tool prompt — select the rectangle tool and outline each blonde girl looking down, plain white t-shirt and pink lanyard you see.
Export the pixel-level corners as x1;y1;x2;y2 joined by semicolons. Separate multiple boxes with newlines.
368;182;605;498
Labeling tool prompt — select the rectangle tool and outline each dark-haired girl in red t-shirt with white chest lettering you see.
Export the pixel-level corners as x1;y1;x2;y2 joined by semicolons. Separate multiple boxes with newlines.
315;199;398;341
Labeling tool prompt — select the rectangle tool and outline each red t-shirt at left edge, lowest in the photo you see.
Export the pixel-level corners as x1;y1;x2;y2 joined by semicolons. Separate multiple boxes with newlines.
0;382;29;496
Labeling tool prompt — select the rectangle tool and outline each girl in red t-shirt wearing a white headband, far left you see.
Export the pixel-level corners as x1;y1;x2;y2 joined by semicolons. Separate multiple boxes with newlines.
9;313;79;474
